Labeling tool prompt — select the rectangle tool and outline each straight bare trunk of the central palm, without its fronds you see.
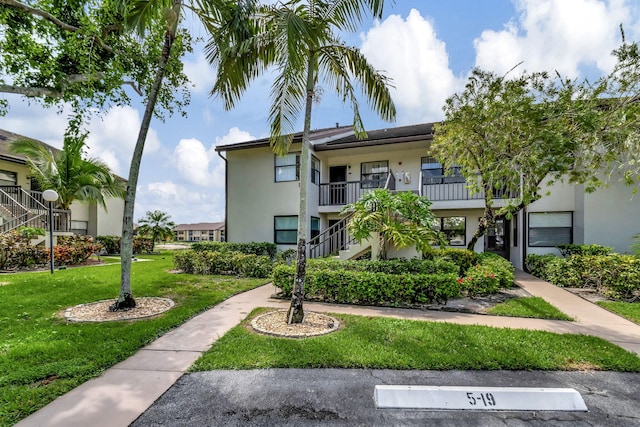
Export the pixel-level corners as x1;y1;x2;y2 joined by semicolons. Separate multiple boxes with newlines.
287;55;315;324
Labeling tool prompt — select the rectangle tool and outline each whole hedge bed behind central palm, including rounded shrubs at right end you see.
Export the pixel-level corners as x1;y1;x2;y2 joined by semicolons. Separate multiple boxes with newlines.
273;249;514;306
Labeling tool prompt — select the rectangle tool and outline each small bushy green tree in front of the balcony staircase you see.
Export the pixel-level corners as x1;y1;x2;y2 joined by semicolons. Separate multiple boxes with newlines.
341;188;444;259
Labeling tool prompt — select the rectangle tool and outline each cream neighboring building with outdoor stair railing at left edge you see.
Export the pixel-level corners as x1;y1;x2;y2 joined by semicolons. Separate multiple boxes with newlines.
0;129;124;244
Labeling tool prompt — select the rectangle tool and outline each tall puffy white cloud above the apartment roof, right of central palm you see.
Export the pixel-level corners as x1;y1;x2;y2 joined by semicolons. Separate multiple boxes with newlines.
361;9;461;124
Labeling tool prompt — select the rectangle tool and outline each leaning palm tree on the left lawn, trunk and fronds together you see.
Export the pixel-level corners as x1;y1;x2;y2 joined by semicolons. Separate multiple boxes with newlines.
109;0;253;311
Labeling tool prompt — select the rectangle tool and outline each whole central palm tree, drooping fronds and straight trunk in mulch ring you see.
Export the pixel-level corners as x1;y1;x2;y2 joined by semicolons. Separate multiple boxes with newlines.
206;0;396;323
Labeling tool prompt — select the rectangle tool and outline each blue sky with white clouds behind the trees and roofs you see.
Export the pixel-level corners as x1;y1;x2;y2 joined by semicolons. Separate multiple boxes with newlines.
0;0;640;223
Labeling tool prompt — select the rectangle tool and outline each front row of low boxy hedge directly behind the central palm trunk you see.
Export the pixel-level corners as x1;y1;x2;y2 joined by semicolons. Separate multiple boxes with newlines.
273;265;462;306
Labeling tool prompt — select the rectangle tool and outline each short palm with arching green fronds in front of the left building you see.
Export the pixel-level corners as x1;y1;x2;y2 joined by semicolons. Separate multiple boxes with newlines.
9;134;125;209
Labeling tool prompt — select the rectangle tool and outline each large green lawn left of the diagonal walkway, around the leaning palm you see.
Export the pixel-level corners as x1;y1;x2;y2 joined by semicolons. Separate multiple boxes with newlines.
0;253;265;426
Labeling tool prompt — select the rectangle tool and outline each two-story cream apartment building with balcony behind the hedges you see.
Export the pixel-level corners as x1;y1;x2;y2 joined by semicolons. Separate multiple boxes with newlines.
216;123;640;267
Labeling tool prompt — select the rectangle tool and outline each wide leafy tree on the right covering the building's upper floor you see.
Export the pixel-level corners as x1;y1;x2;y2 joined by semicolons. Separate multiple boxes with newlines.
431;38;640;250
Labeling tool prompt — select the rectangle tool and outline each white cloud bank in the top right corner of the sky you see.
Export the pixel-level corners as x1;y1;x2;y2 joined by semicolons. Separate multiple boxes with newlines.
474;0;637;78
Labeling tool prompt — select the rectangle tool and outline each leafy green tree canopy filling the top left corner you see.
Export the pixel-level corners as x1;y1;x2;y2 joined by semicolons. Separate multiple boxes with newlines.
0;0;191;115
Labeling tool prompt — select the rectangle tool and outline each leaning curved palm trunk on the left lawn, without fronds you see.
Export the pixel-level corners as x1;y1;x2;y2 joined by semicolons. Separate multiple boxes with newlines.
109;1;181;311
